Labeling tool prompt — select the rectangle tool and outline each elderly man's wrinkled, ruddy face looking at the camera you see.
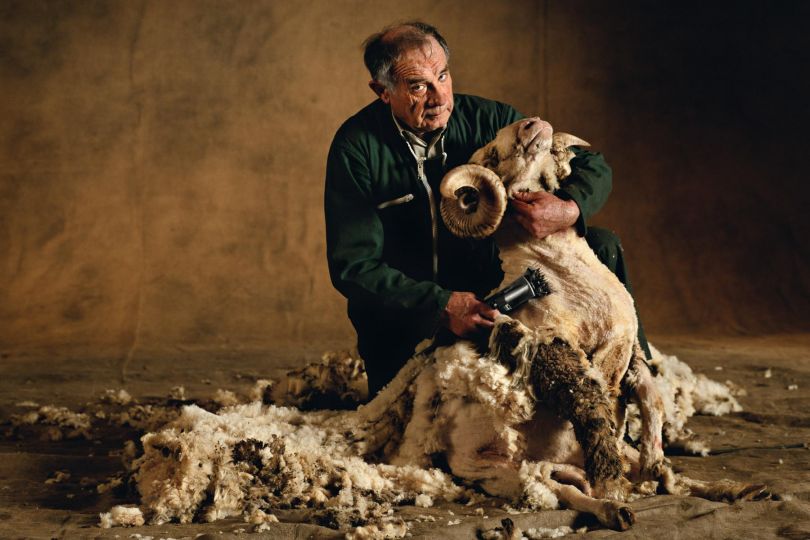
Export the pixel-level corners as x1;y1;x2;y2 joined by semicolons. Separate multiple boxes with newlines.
379;38;453;135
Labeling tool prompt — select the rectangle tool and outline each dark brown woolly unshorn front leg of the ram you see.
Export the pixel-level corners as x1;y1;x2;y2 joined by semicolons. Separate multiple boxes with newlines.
530;339;626;499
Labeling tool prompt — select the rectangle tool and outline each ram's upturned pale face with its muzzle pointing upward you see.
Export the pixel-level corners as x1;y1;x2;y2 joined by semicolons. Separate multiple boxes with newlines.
470;117;553;195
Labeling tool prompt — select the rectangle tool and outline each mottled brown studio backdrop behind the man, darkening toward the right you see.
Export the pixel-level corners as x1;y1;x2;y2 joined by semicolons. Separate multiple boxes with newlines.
0;0;810;358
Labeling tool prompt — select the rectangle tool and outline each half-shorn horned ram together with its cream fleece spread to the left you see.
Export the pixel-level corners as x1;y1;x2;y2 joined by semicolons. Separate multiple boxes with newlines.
129;118;767;534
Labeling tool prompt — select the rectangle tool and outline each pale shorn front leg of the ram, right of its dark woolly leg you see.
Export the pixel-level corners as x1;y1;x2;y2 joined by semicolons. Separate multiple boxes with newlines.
622;341;664;480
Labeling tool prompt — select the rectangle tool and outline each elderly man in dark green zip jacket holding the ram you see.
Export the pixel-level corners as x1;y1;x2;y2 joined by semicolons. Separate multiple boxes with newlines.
324;22;646;396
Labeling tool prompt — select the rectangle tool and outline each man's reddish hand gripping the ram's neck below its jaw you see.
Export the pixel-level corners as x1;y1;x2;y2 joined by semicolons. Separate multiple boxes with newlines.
512;191;579;238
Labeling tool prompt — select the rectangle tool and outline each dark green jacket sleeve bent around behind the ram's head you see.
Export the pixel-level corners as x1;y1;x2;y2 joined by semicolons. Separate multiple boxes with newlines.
554;146;613;236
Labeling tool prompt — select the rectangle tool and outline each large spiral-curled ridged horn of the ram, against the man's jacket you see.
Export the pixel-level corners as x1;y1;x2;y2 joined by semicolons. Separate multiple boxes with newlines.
439;164;506;238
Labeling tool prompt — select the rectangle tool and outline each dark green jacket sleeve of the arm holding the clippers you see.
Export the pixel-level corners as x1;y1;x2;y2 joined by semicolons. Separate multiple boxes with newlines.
324;143;450;328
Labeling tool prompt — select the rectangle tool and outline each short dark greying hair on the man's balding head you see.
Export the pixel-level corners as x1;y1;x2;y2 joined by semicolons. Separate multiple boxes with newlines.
363;21;450;89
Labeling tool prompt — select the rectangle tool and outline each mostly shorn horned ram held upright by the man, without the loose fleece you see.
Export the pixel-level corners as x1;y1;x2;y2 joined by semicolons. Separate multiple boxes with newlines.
432;118;764;528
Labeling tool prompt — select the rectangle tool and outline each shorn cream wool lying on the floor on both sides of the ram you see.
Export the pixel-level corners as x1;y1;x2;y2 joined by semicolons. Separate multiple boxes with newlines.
4;346;740;537
